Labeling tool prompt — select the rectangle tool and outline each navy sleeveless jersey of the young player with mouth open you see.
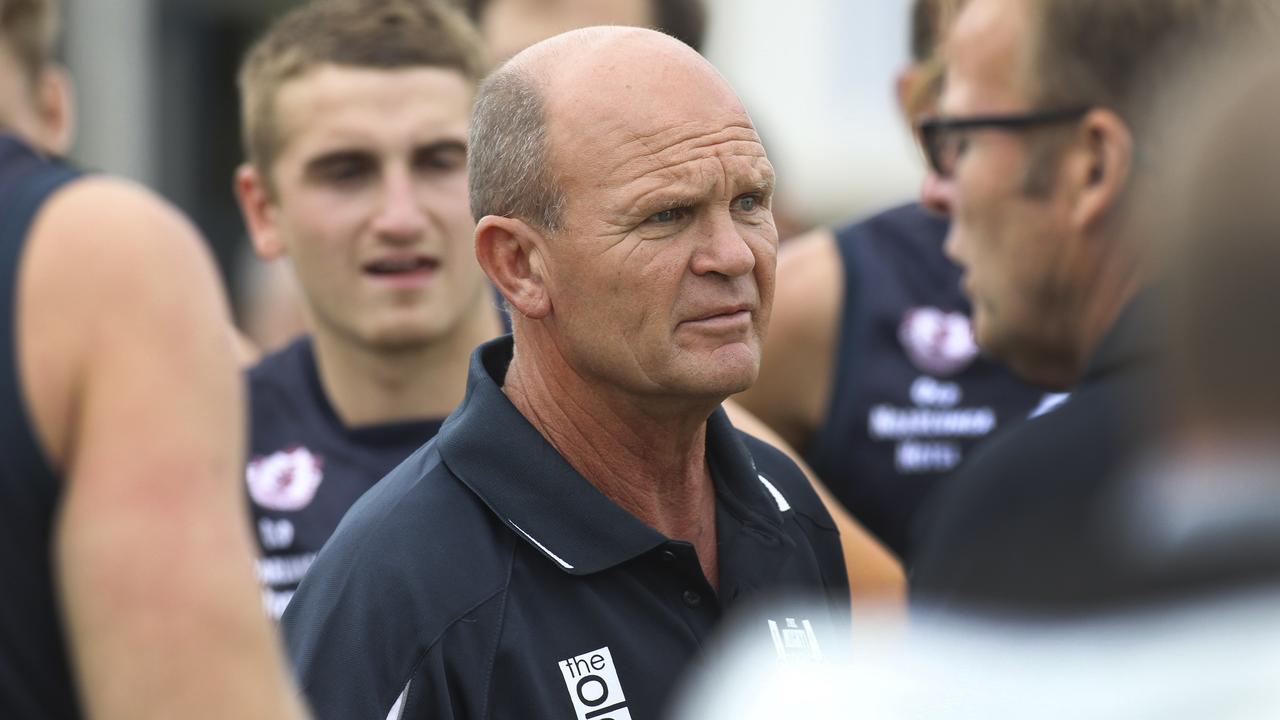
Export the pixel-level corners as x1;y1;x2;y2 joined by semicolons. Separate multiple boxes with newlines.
244;337;444;618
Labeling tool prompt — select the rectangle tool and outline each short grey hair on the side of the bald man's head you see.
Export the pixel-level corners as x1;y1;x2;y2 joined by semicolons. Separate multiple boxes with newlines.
467;63;564;232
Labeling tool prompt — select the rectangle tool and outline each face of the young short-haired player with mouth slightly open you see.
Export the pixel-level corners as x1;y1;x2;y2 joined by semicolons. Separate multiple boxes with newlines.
253;65;488;350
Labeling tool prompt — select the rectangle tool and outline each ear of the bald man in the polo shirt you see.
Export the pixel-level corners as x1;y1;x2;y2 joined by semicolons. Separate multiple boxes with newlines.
476;215;552;320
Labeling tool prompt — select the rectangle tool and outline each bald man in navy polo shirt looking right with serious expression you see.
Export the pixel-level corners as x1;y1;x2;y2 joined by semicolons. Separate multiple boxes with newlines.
283;28;849;720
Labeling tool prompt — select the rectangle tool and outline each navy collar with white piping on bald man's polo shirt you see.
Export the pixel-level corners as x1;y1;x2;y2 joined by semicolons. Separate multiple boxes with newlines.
436;336;785;575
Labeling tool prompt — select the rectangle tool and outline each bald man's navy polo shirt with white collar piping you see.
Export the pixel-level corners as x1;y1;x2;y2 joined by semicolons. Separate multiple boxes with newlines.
283;337;849;720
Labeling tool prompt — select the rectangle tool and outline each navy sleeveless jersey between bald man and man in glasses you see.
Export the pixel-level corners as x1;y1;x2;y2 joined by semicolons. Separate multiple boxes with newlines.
803;204;1044;564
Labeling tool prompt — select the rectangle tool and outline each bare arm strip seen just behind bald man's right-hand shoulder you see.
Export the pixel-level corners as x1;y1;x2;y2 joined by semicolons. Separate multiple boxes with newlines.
724;401;906;605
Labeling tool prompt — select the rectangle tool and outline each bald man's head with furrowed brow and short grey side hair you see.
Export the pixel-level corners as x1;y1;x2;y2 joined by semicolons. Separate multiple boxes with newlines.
471;27;778;397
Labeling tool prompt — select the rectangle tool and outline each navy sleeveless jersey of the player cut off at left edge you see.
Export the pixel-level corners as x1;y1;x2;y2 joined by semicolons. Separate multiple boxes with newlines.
0;133;79;720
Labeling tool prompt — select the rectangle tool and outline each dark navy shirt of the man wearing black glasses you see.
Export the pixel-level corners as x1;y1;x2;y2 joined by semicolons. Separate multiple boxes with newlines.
911;295;1171;614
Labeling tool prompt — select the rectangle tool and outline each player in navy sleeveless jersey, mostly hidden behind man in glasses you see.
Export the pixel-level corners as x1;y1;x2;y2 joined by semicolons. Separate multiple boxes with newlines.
737;0;1044;568
